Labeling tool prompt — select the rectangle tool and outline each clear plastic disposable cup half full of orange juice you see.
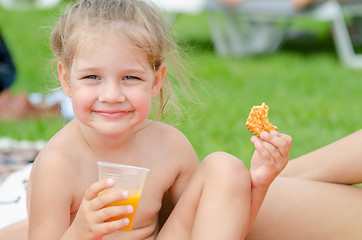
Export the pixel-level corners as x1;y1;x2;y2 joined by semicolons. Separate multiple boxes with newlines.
97;162;150;231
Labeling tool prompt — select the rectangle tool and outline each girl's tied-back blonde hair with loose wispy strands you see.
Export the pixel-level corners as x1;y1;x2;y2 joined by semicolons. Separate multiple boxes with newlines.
51;0;192;118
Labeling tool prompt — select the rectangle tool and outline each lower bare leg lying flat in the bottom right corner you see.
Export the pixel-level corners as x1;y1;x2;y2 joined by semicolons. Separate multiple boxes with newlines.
247;177;362;240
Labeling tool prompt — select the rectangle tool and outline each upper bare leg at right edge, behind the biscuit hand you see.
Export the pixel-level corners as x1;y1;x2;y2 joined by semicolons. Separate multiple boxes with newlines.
281;130;362;184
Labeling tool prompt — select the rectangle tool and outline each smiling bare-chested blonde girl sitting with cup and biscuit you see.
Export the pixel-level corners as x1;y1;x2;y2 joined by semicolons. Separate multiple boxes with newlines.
27;0;291;240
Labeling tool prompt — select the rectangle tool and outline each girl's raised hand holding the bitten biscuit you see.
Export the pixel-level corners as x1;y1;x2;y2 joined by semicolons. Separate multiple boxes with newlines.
250;130;292;188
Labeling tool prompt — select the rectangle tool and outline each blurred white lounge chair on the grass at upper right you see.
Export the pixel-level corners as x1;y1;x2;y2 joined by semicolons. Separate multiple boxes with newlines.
205;0;362;68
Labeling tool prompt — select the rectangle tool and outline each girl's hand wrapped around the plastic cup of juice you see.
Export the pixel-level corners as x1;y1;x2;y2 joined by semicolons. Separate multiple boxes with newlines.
65;179;133;240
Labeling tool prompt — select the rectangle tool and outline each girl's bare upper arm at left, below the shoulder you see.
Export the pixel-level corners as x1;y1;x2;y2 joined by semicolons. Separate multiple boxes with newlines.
27;154;72;240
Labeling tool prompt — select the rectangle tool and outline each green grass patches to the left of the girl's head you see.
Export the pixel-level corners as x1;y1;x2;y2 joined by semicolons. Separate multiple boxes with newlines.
0;4;64;140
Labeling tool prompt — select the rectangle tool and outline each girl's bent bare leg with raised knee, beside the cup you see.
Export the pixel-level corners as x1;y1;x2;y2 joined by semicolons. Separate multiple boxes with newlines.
157;153;251;240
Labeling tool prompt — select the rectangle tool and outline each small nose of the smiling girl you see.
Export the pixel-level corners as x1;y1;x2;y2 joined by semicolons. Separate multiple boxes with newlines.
99;81;126;103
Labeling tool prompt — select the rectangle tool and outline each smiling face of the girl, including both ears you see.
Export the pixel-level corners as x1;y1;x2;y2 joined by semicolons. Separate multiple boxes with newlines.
58;33;166;135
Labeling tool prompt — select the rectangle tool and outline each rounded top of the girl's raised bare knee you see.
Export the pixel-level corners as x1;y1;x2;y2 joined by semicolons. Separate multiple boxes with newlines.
200;152;251;191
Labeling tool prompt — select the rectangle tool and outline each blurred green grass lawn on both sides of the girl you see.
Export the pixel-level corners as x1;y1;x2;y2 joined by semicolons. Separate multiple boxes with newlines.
0;6;362;167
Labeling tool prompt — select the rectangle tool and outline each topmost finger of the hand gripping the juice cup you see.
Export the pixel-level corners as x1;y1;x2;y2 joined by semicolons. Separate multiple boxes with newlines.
93;190;129;211
